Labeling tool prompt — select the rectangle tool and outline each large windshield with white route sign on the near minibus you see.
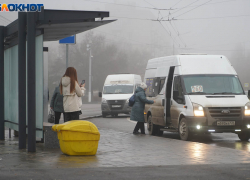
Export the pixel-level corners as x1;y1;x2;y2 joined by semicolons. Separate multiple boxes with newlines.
182;75;244;95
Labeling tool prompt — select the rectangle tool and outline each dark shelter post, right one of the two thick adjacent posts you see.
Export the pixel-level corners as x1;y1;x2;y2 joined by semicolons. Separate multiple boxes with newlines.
27;12;36;152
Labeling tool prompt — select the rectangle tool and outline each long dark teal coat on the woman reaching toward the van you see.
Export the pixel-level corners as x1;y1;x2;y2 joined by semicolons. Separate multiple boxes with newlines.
130;87;154;122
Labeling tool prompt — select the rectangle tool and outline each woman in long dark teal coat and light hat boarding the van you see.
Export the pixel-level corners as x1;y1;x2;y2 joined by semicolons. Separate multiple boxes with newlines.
130;83;154;134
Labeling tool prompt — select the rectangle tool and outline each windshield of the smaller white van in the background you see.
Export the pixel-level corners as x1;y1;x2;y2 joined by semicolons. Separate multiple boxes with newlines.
103;84;134;94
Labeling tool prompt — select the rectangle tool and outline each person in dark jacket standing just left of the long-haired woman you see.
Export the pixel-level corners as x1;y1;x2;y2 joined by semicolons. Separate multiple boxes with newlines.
50;85;64;124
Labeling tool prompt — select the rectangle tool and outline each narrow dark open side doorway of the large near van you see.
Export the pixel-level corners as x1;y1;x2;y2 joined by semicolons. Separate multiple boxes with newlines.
164;66;175;126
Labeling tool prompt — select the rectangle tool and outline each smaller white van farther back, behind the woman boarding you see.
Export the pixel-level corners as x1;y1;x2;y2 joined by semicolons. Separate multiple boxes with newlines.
100;74;142;117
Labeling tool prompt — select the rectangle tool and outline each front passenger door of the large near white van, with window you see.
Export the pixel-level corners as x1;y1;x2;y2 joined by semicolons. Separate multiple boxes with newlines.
170;76;185;128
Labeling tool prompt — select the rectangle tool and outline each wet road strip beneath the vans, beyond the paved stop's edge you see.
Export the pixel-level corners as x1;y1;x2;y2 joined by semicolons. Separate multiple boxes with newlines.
90;115;250;152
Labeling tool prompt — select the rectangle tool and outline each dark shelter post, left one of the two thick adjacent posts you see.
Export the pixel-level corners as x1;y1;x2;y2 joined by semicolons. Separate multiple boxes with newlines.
18;12;27;149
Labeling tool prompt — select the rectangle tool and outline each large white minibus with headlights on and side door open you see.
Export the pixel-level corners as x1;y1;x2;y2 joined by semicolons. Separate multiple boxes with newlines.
144;55;250;141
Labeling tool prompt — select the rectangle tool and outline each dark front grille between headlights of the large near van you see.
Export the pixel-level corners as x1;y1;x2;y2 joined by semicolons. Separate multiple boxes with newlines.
208;107;241;118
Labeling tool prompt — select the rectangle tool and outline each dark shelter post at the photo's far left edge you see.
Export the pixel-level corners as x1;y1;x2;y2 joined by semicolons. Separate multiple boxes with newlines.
0;26;4;140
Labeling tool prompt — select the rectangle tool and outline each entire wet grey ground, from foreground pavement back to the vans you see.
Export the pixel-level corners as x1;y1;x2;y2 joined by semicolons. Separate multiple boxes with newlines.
0;115;250;180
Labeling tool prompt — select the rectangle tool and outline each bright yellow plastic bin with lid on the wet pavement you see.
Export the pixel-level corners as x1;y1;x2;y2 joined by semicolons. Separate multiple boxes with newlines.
52;120;100;155
